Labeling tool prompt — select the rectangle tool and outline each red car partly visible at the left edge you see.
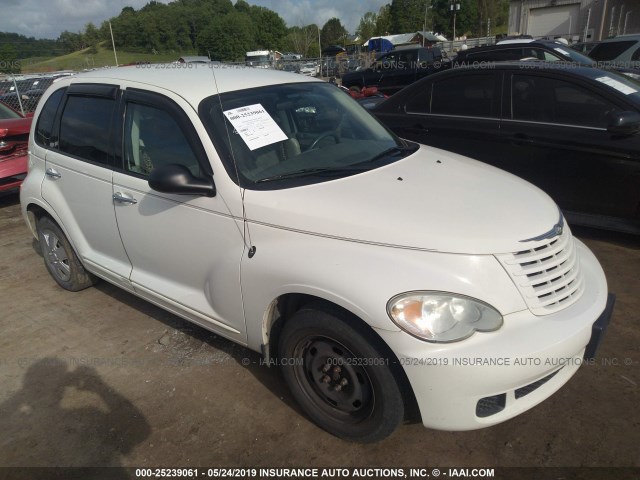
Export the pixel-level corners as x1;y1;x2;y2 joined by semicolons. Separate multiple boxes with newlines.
0;103;33;192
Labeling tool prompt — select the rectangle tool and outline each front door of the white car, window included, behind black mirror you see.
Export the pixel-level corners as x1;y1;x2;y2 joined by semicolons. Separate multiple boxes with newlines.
113;89;246;343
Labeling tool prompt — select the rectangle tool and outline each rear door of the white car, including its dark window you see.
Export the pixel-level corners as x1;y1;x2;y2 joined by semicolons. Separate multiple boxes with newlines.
42;84;131;288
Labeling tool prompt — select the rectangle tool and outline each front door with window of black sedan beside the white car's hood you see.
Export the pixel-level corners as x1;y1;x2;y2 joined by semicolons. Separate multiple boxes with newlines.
499;72;640;226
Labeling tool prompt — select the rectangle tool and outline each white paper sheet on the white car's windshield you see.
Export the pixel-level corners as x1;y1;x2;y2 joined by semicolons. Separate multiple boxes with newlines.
223;103;289;150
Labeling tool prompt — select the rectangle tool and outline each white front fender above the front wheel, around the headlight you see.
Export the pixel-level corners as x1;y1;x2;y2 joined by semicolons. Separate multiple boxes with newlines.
241;224;526;351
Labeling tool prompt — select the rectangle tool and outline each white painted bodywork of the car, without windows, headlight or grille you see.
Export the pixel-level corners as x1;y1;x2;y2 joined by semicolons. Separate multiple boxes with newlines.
21;64;607;430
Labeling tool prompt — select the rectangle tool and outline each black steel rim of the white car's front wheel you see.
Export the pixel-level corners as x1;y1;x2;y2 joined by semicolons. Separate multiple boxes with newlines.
297;337;373;421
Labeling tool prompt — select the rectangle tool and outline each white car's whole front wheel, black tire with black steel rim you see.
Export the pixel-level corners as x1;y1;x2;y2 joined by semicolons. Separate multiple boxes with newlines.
278;307;404;443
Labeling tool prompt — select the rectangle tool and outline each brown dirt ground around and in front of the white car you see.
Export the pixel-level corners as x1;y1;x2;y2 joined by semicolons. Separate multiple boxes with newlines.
0;191;640;478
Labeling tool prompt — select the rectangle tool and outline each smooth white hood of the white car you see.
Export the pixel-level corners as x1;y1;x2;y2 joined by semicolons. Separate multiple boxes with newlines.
244;146;559;254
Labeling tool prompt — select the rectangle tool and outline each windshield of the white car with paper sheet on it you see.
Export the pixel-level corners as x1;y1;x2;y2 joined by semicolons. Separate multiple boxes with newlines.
199;82;417;190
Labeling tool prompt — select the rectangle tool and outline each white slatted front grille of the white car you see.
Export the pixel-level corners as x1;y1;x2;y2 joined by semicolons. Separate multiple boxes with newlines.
496;226;584;315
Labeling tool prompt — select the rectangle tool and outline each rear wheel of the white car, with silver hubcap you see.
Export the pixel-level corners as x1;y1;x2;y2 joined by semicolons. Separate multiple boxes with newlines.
38;216;97;292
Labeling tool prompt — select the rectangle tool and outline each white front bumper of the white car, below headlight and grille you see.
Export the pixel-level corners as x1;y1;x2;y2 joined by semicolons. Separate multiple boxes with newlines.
378;240;614;430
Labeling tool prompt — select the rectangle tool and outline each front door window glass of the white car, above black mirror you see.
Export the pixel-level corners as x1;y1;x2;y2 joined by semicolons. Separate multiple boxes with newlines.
124;103;202;177
